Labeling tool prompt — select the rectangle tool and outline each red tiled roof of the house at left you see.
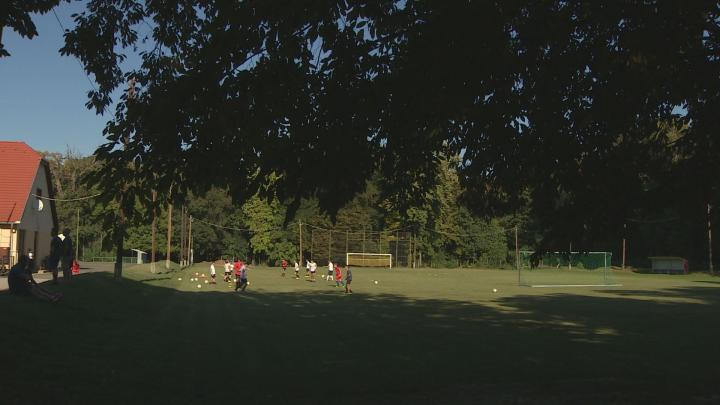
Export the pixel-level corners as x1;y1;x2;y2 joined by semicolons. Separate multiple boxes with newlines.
0;141;42;222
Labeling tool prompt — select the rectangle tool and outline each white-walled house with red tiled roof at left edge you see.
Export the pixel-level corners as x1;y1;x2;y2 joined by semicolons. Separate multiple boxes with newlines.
0;141;57;268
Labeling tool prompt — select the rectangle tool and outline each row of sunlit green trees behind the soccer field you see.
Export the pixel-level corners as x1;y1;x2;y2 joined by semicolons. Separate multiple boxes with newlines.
45;144;717;269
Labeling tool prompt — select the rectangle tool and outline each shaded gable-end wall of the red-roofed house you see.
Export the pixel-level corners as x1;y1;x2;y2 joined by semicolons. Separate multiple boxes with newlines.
13;164;53;264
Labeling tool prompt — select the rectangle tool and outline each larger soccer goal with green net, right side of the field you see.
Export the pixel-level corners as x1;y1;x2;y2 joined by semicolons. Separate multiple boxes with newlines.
518;251;621;288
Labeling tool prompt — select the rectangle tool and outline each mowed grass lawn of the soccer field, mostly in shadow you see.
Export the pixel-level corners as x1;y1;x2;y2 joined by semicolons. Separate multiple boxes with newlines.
0;263;720;404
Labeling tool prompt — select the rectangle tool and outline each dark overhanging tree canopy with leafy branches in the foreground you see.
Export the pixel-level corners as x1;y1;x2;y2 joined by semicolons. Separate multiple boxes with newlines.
40;0;720;251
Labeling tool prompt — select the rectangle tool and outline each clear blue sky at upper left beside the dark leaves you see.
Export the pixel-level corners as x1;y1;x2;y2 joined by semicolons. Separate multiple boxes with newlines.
0;2;114;156
